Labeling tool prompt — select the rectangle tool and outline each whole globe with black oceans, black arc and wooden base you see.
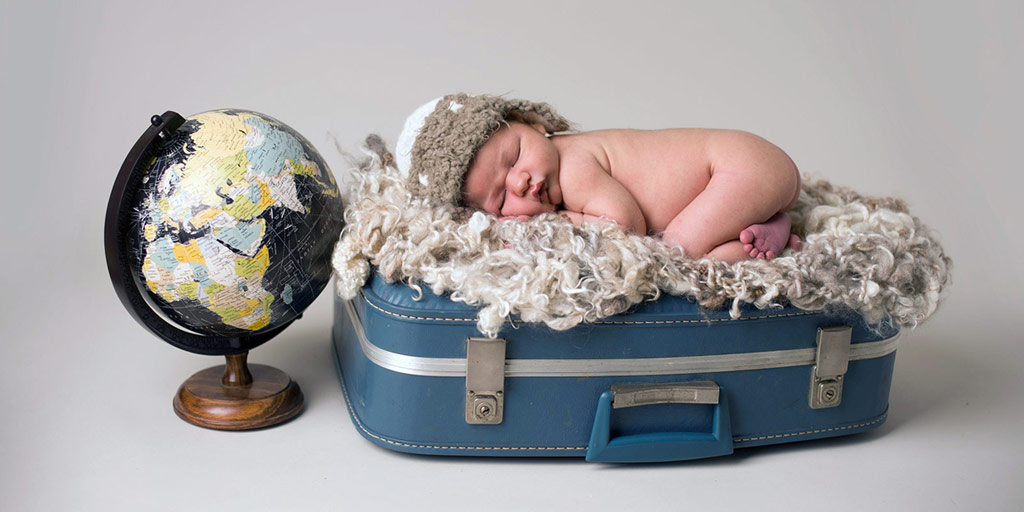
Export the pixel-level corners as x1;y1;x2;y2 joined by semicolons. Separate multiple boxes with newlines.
103;110;343;430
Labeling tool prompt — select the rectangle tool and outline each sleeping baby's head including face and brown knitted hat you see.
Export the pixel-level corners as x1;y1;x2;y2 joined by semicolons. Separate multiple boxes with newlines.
395;94;569;215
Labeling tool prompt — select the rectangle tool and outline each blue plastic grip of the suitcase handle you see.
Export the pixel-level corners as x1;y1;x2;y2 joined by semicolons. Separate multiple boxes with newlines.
587;390;732;462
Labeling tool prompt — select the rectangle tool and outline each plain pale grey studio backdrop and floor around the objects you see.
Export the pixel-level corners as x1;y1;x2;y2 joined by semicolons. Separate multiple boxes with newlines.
0;0;1024;510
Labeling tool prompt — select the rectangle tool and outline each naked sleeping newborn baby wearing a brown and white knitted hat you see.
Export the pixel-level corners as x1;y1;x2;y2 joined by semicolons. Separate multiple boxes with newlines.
396;94;801;262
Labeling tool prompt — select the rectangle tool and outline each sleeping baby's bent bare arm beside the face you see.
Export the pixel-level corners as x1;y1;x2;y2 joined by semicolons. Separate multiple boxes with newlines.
559;157;647;234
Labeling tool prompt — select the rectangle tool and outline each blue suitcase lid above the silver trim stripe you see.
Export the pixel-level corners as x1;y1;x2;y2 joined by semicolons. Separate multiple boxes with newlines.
354;273;898;359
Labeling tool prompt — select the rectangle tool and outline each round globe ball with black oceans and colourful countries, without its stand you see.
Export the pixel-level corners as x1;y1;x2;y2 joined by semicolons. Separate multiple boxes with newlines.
129;110;342;336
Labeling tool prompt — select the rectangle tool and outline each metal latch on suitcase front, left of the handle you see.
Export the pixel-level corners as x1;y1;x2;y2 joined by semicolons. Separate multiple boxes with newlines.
466;338;505;425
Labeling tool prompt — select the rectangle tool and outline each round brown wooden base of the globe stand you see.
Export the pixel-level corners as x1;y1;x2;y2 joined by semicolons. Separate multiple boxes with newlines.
174;352;303;430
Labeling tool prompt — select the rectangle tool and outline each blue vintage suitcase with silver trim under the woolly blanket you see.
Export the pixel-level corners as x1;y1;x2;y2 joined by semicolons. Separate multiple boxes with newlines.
332;274;899;462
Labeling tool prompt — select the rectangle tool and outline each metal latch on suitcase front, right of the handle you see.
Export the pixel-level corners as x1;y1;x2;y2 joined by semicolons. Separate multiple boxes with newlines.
809;326;852;409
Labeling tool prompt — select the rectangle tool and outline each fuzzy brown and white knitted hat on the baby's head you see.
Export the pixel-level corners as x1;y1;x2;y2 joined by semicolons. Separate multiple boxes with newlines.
395;93;569;205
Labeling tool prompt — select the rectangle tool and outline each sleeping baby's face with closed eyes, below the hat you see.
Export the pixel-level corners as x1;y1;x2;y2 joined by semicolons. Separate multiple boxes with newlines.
463;122;562;216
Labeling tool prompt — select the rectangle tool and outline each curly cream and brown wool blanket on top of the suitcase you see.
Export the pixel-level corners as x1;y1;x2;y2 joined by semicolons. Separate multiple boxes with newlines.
332;143;951;337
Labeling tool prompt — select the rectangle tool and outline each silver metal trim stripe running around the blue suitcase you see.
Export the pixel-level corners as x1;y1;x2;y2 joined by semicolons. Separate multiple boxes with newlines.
345;300;900;378
